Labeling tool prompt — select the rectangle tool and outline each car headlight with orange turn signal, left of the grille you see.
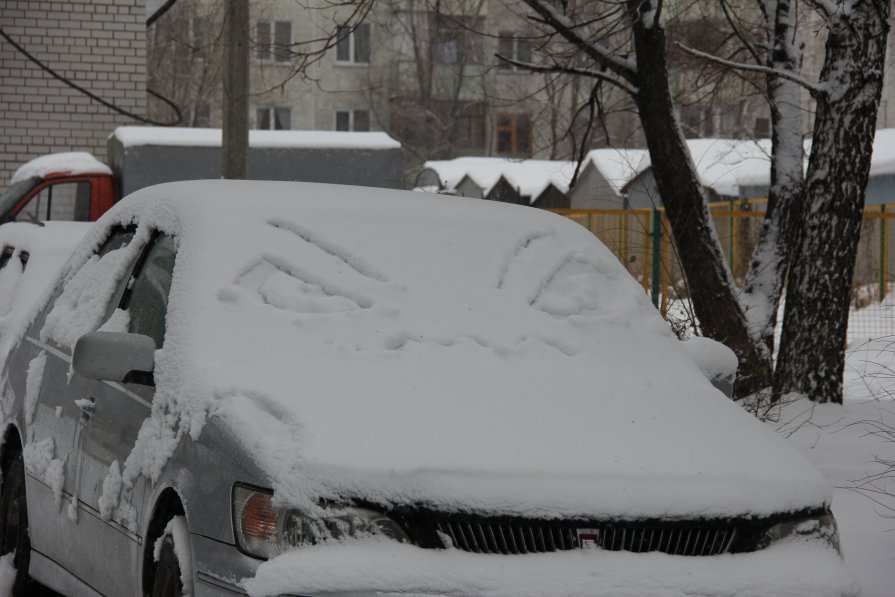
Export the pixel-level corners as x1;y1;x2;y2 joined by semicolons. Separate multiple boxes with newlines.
233;485;408;558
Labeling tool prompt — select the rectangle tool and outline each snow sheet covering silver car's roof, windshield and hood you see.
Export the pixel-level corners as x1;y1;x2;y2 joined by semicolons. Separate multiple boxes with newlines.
73;181;830;517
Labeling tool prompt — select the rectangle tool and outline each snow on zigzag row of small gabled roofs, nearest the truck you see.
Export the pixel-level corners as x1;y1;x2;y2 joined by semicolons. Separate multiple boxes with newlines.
423;157;575;201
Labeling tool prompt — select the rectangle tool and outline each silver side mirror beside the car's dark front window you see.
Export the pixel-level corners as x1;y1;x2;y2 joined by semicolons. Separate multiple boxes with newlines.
72;332;156;385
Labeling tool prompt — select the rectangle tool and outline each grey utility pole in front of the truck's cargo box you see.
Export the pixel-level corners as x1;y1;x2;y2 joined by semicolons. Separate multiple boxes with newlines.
221;0;249;179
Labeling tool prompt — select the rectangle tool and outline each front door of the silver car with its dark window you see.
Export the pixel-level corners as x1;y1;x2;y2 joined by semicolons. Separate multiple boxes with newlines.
70;234;176;595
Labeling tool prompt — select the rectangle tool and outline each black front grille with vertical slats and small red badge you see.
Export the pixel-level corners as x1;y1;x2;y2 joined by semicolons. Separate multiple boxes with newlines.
435;520;737;556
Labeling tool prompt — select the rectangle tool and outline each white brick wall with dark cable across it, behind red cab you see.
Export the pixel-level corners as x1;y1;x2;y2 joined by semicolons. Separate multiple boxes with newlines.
0;0;146;184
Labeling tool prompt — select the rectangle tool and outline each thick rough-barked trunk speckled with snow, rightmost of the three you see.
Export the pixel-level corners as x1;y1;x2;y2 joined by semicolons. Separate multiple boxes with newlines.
774;0;890;403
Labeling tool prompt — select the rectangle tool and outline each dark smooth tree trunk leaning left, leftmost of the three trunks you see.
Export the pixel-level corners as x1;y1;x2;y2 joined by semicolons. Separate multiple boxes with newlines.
628;0;771;397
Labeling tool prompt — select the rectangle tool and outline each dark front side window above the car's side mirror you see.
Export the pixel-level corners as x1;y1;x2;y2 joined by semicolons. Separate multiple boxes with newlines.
121;234;177;348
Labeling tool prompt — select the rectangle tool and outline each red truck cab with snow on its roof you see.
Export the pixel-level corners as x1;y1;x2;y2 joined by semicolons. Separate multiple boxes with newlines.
0;152;117;223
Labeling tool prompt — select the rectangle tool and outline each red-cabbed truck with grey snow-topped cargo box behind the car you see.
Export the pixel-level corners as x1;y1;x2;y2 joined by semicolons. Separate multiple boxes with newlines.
0;126;404;223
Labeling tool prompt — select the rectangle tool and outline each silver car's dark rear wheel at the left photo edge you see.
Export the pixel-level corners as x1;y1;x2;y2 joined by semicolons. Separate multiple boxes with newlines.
0;450;34;595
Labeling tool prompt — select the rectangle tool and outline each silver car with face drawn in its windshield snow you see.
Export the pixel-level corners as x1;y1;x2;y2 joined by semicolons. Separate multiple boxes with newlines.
0;181;858;597
